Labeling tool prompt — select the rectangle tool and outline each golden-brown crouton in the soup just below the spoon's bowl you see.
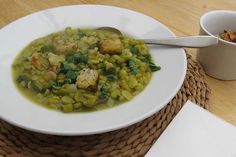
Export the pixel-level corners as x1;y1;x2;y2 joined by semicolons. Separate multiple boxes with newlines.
99;39;122;54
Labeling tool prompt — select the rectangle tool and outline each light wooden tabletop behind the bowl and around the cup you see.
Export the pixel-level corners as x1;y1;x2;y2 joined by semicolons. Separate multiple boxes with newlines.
0;0;236;125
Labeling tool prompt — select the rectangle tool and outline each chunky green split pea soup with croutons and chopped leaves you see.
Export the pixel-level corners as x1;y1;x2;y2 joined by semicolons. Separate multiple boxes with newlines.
12;27;160;112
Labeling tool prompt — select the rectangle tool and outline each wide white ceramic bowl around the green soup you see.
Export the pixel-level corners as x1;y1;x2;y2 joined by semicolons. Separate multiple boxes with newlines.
0;5;187;135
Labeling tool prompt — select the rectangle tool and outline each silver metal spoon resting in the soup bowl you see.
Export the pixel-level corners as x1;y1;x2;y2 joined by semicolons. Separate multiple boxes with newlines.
97;27;218;48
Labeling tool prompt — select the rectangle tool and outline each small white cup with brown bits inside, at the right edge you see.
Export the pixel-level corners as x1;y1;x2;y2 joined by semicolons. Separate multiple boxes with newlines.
197;10;236;80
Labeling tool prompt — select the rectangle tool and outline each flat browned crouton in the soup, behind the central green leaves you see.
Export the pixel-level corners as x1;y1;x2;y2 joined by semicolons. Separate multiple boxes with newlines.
56;43;78;55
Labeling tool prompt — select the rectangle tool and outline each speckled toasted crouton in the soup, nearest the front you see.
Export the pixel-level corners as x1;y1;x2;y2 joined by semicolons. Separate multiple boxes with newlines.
76;68;98;91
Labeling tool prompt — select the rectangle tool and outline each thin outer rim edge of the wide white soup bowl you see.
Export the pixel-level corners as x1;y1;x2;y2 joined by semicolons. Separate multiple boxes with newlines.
0;4;187;136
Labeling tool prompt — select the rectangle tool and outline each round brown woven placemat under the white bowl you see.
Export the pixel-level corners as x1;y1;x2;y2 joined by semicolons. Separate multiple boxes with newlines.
0;55;210;157
